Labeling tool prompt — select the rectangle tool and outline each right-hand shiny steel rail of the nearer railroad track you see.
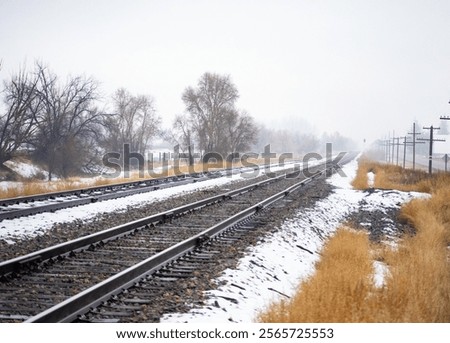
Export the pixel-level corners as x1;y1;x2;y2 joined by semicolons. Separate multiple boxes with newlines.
25;169;327;323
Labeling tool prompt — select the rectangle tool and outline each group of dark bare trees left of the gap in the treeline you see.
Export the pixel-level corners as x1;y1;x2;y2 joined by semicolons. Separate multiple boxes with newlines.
0;63;161;179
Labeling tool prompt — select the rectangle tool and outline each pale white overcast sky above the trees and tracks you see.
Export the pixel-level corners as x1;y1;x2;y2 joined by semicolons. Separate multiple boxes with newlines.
0;0;450;148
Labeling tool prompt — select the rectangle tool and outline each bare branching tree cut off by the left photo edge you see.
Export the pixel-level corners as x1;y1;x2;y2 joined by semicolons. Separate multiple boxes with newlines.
0;69;40;164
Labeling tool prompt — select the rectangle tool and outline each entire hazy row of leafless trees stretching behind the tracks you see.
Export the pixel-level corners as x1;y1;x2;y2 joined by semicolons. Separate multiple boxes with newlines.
0;62;356;179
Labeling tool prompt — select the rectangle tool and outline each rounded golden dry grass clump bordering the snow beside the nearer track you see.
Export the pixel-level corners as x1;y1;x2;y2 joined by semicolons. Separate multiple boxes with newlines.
258;228;373;323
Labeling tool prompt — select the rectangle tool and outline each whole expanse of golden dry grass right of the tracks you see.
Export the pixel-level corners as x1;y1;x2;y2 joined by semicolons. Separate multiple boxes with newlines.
258;161;450;323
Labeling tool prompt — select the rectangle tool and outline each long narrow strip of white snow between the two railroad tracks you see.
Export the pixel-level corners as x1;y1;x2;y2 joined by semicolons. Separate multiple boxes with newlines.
0;161;308;244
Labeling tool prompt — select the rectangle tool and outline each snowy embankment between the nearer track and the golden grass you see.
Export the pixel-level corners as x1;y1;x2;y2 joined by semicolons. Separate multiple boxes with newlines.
161;160;426;323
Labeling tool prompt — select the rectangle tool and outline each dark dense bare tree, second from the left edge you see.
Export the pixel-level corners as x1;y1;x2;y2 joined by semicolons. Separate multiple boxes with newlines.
30;63;104;180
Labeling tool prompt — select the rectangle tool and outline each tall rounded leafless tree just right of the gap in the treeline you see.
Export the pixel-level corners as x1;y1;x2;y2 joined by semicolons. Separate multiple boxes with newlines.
182;73;258;156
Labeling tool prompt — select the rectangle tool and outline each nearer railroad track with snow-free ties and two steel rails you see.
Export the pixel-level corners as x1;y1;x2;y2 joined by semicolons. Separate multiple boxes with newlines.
0;155;352;322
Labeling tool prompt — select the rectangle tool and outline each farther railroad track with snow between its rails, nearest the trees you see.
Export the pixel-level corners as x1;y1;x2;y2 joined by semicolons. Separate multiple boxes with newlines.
0;162;293;221
